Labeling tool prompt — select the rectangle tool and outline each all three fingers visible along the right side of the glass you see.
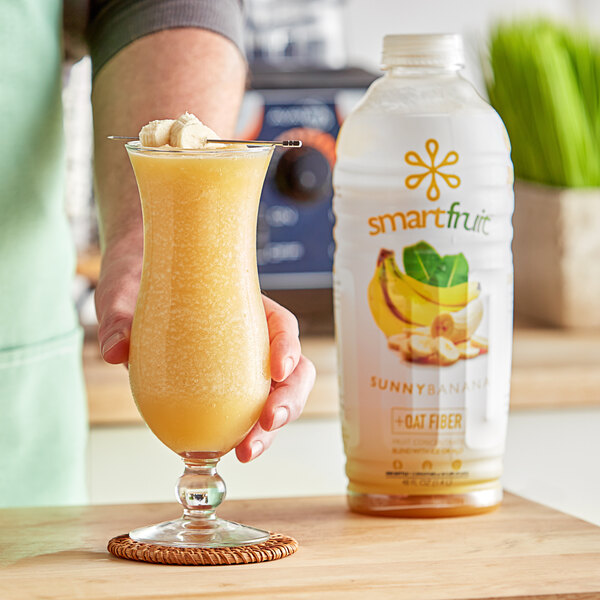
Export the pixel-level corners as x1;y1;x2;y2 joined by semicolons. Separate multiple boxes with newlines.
235;296;316;462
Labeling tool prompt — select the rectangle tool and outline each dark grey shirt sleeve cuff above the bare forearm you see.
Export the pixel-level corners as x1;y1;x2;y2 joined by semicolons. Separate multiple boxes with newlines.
87;0;244;77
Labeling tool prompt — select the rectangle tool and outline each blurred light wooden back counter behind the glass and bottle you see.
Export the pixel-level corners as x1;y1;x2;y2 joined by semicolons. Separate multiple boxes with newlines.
83;325;600;425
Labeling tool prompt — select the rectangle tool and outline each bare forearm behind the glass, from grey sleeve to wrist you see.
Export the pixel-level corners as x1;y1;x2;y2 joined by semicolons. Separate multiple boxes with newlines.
92;28;246;254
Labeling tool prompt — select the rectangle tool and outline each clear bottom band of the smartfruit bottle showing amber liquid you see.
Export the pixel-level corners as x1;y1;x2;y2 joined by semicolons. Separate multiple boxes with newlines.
347;487;502;518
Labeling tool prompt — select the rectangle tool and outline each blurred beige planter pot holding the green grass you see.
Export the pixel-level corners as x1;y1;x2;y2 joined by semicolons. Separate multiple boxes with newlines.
513;181;600;328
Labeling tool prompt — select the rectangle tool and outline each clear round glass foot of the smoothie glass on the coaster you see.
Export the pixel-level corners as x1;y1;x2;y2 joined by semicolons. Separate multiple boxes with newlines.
129;517;269;548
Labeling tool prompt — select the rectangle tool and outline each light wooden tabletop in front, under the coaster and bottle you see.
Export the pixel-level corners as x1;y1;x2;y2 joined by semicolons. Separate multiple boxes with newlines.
0;494;600;600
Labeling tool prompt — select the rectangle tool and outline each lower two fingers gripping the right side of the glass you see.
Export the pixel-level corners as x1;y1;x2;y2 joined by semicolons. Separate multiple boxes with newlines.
236;356;316;462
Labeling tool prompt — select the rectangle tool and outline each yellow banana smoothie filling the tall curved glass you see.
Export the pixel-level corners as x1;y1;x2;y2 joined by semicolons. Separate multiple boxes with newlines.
129;148;271;455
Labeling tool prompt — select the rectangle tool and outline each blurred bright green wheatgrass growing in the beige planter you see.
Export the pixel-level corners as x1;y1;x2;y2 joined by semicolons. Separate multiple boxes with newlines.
486;21;600;187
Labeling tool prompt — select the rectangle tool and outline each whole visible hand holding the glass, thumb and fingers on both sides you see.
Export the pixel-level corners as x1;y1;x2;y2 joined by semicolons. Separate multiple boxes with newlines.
96;248;315;462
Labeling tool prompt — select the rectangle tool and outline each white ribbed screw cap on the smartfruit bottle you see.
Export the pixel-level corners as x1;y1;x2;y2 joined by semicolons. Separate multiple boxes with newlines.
382;33;465;69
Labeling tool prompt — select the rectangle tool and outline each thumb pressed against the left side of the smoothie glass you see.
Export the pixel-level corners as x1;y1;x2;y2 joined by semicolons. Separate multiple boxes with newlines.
95;250;141;364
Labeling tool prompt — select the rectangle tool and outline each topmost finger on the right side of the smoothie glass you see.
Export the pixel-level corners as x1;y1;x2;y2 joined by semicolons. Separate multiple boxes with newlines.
263;296;301;382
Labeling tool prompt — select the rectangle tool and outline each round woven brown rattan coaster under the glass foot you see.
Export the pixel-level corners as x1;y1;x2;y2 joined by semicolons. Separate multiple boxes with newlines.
108;533;298;566
